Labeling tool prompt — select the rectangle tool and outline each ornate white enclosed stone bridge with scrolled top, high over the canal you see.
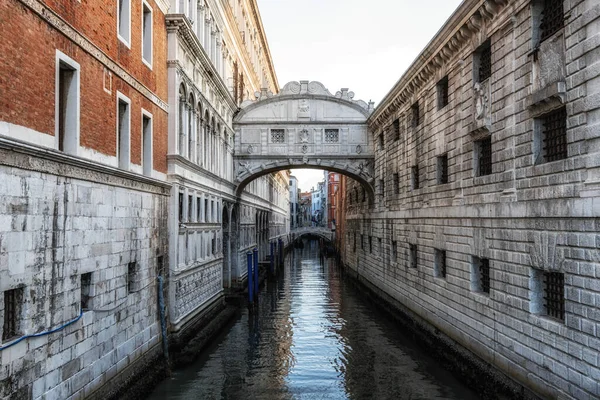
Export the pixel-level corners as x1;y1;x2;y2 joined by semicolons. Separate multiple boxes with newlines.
234;81;374;201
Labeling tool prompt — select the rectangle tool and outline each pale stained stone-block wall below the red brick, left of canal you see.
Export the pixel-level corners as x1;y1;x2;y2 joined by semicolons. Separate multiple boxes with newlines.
0;150;168;399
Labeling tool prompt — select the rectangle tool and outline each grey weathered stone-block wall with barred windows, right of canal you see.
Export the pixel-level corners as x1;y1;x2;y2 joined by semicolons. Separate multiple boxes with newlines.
344;0;600;399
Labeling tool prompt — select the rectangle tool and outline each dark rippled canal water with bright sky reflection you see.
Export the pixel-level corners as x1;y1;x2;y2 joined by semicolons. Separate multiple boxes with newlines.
150;241;478;400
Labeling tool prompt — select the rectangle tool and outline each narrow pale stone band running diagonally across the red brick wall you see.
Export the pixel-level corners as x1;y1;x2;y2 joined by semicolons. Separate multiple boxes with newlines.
20;0;169;112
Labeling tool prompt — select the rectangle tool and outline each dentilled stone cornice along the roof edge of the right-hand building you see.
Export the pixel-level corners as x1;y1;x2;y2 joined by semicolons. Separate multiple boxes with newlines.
368;0;514;130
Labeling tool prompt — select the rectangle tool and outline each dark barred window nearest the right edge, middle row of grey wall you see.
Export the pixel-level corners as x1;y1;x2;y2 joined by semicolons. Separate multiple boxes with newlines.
536;107;568;162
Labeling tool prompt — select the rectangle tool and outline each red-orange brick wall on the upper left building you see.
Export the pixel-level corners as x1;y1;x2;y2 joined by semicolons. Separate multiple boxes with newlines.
0;0;168;172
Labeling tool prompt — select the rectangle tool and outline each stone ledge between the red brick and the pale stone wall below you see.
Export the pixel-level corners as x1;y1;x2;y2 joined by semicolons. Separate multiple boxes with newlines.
0;137;171;196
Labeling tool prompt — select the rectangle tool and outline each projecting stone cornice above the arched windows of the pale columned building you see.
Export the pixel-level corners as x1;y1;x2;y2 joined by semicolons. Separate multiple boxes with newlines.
166;14;237;113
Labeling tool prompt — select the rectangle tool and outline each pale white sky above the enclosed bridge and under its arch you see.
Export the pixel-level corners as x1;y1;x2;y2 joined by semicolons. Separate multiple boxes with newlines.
257;0;460;191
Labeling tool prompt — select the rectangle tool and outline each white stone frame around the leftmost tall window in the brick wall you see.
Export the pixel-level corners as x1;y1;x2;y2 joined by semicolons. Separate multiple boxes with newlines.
53;50;81;155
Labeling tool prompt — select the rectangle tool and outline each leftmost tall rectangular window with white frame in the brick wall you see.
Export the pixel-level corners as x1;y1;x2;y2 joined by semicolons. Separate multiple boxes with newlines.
55;50;80;154
